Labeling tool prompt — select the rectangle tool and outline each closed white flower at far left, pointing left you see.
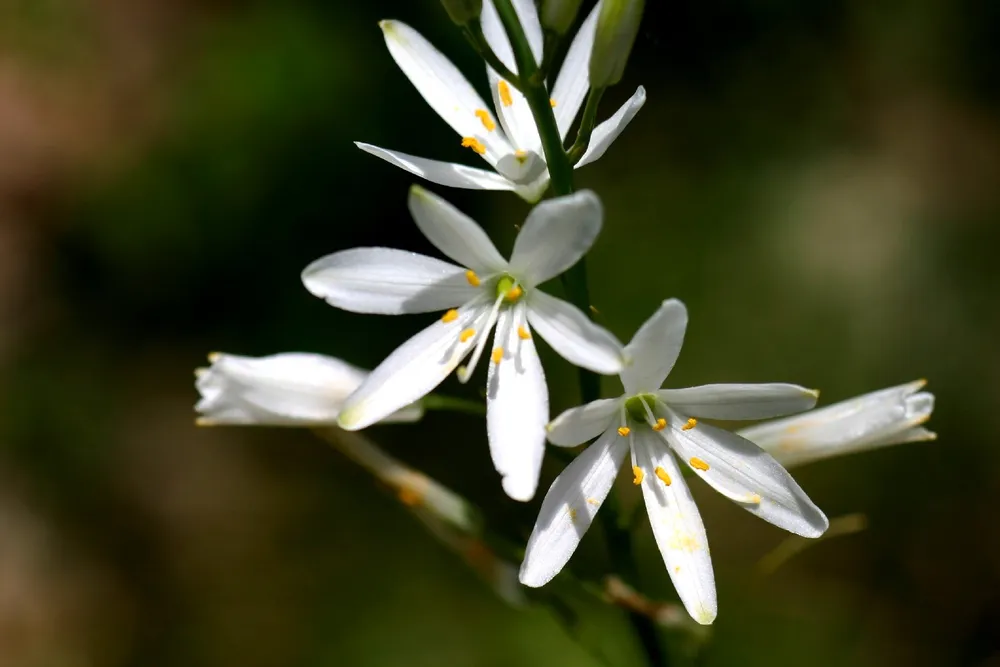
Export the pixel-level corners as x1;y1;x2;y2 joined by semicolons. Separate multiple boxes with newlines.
195;352;423;426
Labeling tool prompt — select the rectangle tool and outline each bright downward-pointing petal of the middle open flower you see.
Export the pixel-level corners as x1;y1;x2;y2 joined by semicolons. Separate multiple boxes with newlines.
486;304;549;501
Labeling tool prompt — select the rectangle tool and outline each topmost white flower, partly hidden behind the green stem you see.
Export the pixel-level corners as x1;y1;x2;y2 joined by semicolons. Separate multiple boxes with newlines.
357;0;646;202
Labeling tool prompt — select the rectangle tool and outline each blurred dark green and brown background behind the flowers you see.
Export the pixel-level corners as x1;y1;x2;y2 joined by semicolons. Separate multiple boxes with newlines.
0;0;1000;667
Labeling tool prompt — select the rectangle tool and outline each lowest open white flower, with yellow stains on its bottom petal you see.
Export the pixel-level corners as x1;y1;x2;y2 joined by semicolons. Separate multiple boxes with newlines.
520;299;828;624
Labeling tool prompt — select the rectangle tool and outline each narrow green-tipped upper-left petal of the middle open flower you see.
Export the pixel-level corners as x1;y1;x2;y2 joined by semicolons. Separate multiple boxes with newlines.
409;185;507;273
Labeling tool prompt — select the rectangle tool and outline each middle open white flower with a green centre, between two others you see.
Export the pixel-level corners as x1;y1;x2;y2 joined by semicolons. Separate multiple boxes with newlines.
302;186;622;500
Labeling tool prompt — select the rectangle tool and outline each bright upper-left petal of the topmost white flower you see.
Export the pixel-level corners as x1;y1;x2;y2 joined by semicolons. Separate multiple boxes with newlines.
379;21;510;164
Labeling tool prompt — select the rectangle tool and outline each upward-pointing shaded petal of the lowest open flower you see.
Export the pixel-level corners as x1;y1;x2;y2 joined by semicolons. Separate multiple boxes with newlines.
621;299;687;394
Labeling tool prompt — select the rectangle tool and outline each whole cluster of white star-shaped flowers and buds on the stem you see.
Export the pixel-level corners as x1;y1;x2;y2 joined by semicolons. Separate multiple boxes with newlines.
196;0;934;624
